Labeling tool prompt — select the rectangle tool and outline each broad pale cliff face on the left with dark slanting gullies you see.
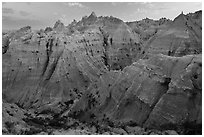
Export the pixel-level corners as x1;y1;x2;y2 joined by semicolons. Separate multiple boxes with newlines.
2;27;107;112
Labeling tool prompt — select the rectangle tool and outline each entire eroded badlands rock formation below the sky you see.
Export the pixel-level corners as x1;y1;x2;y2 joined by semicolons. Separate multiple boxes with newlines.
2;11;202;135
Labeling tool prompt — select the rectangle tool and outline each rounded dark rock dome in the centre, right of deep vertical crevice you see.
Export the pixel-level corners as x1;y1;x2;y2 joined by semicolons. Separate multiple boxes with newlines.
103;24;141;70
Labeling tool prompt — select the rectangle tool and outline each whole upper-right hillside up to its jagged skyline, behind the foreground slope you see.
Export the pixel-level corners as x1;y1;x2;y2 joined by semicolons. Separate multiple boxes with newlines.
127;11;202;58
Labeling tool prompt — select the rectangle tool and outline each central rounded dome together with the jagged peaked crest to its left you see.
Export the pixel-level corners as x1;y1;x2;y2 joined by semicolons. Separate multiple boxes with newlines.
69;13;142;70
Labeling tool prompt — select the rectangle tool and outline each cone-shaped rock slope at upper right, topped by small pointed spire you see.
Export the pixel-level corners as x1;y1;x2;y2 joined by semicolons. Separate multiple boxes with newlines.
141;11;202;56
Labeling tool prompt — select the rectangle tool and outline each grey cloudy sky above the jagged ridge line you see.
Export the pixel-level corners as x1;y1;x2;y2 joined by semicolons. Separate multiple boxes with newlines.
2;2;202;30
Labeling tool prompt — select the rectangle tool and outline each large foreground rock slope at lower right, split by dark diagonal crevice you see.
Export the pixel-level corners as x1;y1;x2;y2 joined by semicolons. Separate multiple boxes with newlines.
70;55;202;129
